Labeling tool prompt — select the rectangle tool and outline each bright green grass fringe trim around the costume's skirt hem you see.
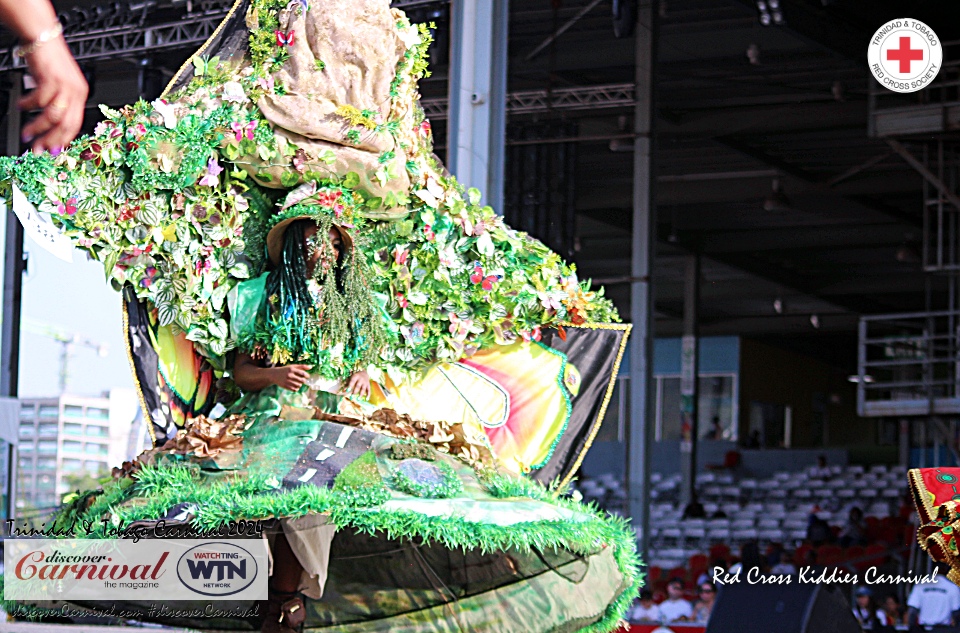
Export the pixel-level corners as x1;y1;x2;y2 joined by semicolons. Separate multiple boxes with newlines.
33;465;643;633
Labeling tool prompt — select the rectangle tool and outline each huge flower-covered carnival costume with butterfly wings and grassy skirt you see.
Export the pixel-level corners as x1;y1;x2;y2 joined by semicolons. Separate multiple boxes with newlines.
0;0;640;632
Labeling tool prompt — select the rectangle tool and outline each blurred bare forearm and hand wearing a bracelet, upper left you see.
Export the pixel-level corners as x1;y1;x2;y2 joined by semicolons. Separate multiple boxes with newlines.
0;0;89;152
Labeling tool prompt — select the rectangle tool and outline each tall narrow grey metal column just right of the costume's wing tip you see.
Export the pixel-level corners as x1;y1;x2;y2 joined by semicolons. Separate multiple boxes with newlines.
627;0;656;560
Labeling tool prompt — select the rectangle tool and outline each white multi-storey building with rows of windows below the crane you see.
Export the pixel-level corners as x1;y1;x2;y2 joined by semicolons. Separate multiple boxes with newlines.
17;389;139;512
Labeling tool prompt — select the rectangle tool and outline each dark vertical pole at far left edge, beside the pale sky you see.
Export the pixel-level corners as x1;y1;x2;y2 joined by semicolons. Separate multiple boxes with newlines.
0;72;23;519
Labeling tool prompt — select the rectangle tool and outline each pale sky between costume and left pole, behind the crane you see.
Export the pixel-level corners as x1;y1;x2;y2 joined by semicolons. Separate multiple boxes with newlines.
17;230;133;397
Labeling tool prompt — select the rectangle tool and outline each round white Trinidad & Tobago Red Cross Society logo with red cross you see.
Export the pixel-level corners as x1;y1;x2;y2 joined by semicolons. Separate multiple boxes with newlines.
867;18;943;92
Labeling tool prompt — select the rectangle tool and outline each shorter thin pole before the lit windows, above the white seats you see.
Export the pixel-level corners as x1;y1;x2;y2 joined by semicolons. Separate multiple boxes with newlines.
680;253;700;507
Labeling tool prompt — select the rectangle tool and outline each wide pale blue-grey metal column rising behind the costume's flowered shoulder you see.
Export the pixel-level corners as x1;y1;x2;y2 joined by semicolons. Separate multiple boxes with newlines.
447;0;509;213
